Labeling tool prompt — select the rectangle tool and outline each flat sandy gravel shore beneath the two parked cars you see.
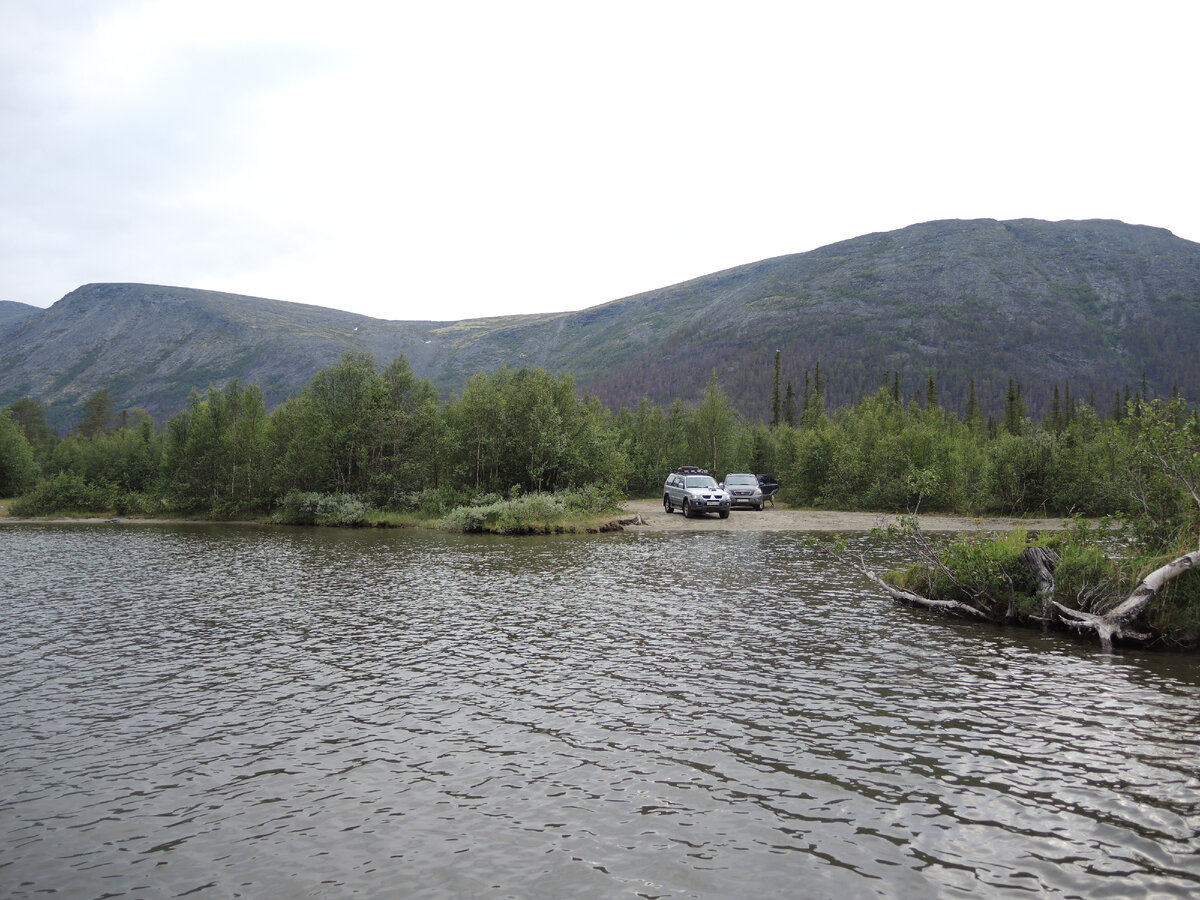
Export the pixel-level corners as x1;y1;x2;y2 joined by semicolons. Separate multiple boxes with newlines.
622;500;1063;532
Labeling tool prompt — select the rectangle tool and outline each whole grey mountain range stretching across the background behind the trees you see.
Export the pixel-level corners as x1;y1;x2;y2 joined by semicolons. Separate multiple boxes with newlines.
0;220;1200;426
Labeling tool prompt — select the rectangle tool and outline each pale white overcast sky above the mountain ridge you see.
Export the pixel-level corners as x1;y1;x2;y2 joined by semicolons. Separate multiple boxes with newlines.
0;0;1200;320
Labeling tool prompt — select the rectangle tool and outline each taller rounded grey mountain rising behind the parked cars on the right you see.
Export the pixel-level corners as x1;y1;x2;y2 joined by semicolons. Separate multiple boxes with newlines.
583;220;1200;418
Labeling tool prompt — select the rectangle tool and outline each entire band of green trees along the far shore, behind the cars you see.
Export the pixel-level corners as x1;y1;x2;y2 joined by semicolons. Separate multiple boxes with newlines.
0;354;1200;547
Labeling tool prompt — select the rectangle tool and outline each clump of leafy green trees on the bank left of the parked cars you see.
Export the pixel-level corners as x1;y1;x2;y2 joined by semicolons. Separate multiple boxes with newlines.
0;353;625;517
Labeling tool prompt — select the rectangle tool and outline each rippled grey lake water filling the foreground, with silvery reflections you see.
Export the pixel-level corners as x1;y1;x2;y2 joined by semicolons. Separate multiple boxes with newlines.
0;526;1200;898
